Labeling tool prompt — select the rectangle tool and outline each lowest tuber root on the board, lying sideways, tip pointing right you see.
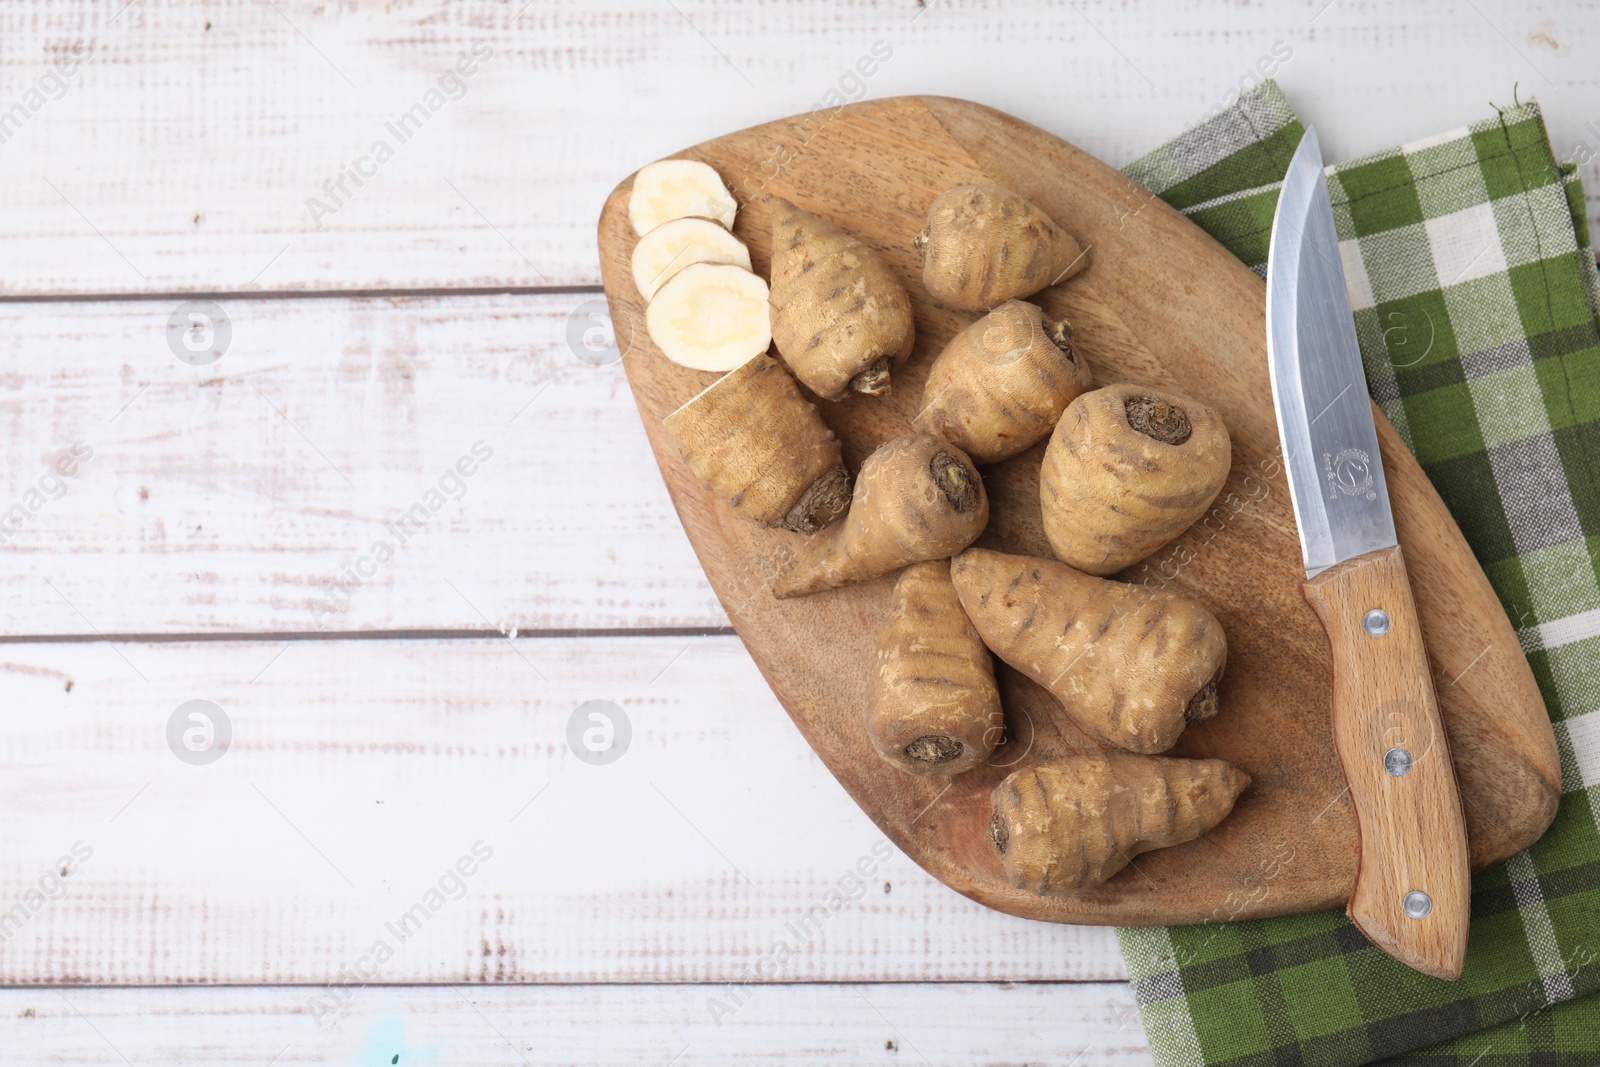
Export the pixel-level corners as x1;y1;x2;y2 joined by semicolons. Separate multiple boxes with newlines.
989;753;1250;896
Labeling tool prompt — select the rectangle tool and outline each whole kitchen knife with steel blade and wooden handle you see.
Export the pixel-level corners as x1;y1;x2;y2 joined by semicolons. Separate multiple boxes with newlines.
1267;126;1470;979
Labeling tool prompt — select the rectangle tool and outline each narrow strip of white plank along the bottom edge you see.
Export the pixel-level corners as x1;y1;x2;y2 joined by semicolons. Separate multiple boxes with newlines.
0;982;1154;1067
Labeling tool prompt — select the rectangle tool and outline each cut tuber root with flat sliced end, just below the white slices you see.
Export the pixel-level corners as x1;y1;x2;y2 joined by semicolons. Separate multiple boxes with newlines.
664;354;850;534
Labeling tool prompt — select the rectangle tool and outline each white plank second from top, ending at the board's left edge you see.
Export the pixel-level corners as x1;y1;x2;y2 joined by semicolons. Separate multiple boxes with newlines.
0;294;726;635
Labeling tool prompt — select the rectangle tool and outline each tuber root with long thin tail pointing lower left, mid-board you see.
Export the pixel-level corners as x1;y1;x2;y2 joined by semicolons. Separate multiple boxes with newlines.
773;434;989;598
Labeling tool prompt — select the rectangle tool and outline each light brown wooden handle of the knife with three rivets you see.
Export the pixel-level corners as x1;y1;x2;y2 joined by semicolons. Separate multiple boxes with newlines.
1304;545;1472;979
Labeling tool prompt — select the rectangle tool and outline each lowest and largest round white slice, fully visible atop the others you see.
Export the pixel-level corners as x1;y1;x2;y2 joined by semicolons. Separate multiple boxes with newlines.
645;262;773;371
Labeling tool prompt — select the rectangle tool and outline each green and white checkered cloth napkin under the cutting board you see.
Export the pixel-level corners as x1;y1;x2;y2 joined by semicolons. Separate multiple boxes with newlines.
1118;82;1600;1067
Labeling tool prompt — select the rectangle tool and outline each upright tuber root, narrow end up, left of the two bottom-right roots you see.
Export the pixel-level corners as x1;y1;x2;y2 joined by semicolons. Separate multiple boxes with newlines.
867;560;1005;776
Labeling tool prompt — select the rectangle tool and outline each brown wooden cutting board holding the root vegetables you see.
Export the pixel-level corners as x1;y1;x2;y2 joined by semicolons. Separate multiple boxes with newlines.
600;96;1560;925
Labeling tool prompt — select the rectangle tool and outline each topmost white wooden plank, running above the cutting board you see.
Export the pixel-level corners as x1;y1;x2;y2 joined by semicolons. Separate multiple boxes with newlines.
0;0;1600;293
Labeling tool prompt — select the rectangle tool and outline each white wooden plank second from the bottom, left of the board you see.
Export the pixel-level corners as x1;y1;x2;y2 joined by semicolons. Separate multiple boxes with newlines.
0;637;1125;991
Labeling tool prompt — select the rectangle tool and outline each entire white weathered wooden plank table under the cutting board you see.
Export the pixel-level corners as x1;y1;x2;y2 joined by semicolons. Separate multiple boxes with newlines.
0;0;1600;1067
